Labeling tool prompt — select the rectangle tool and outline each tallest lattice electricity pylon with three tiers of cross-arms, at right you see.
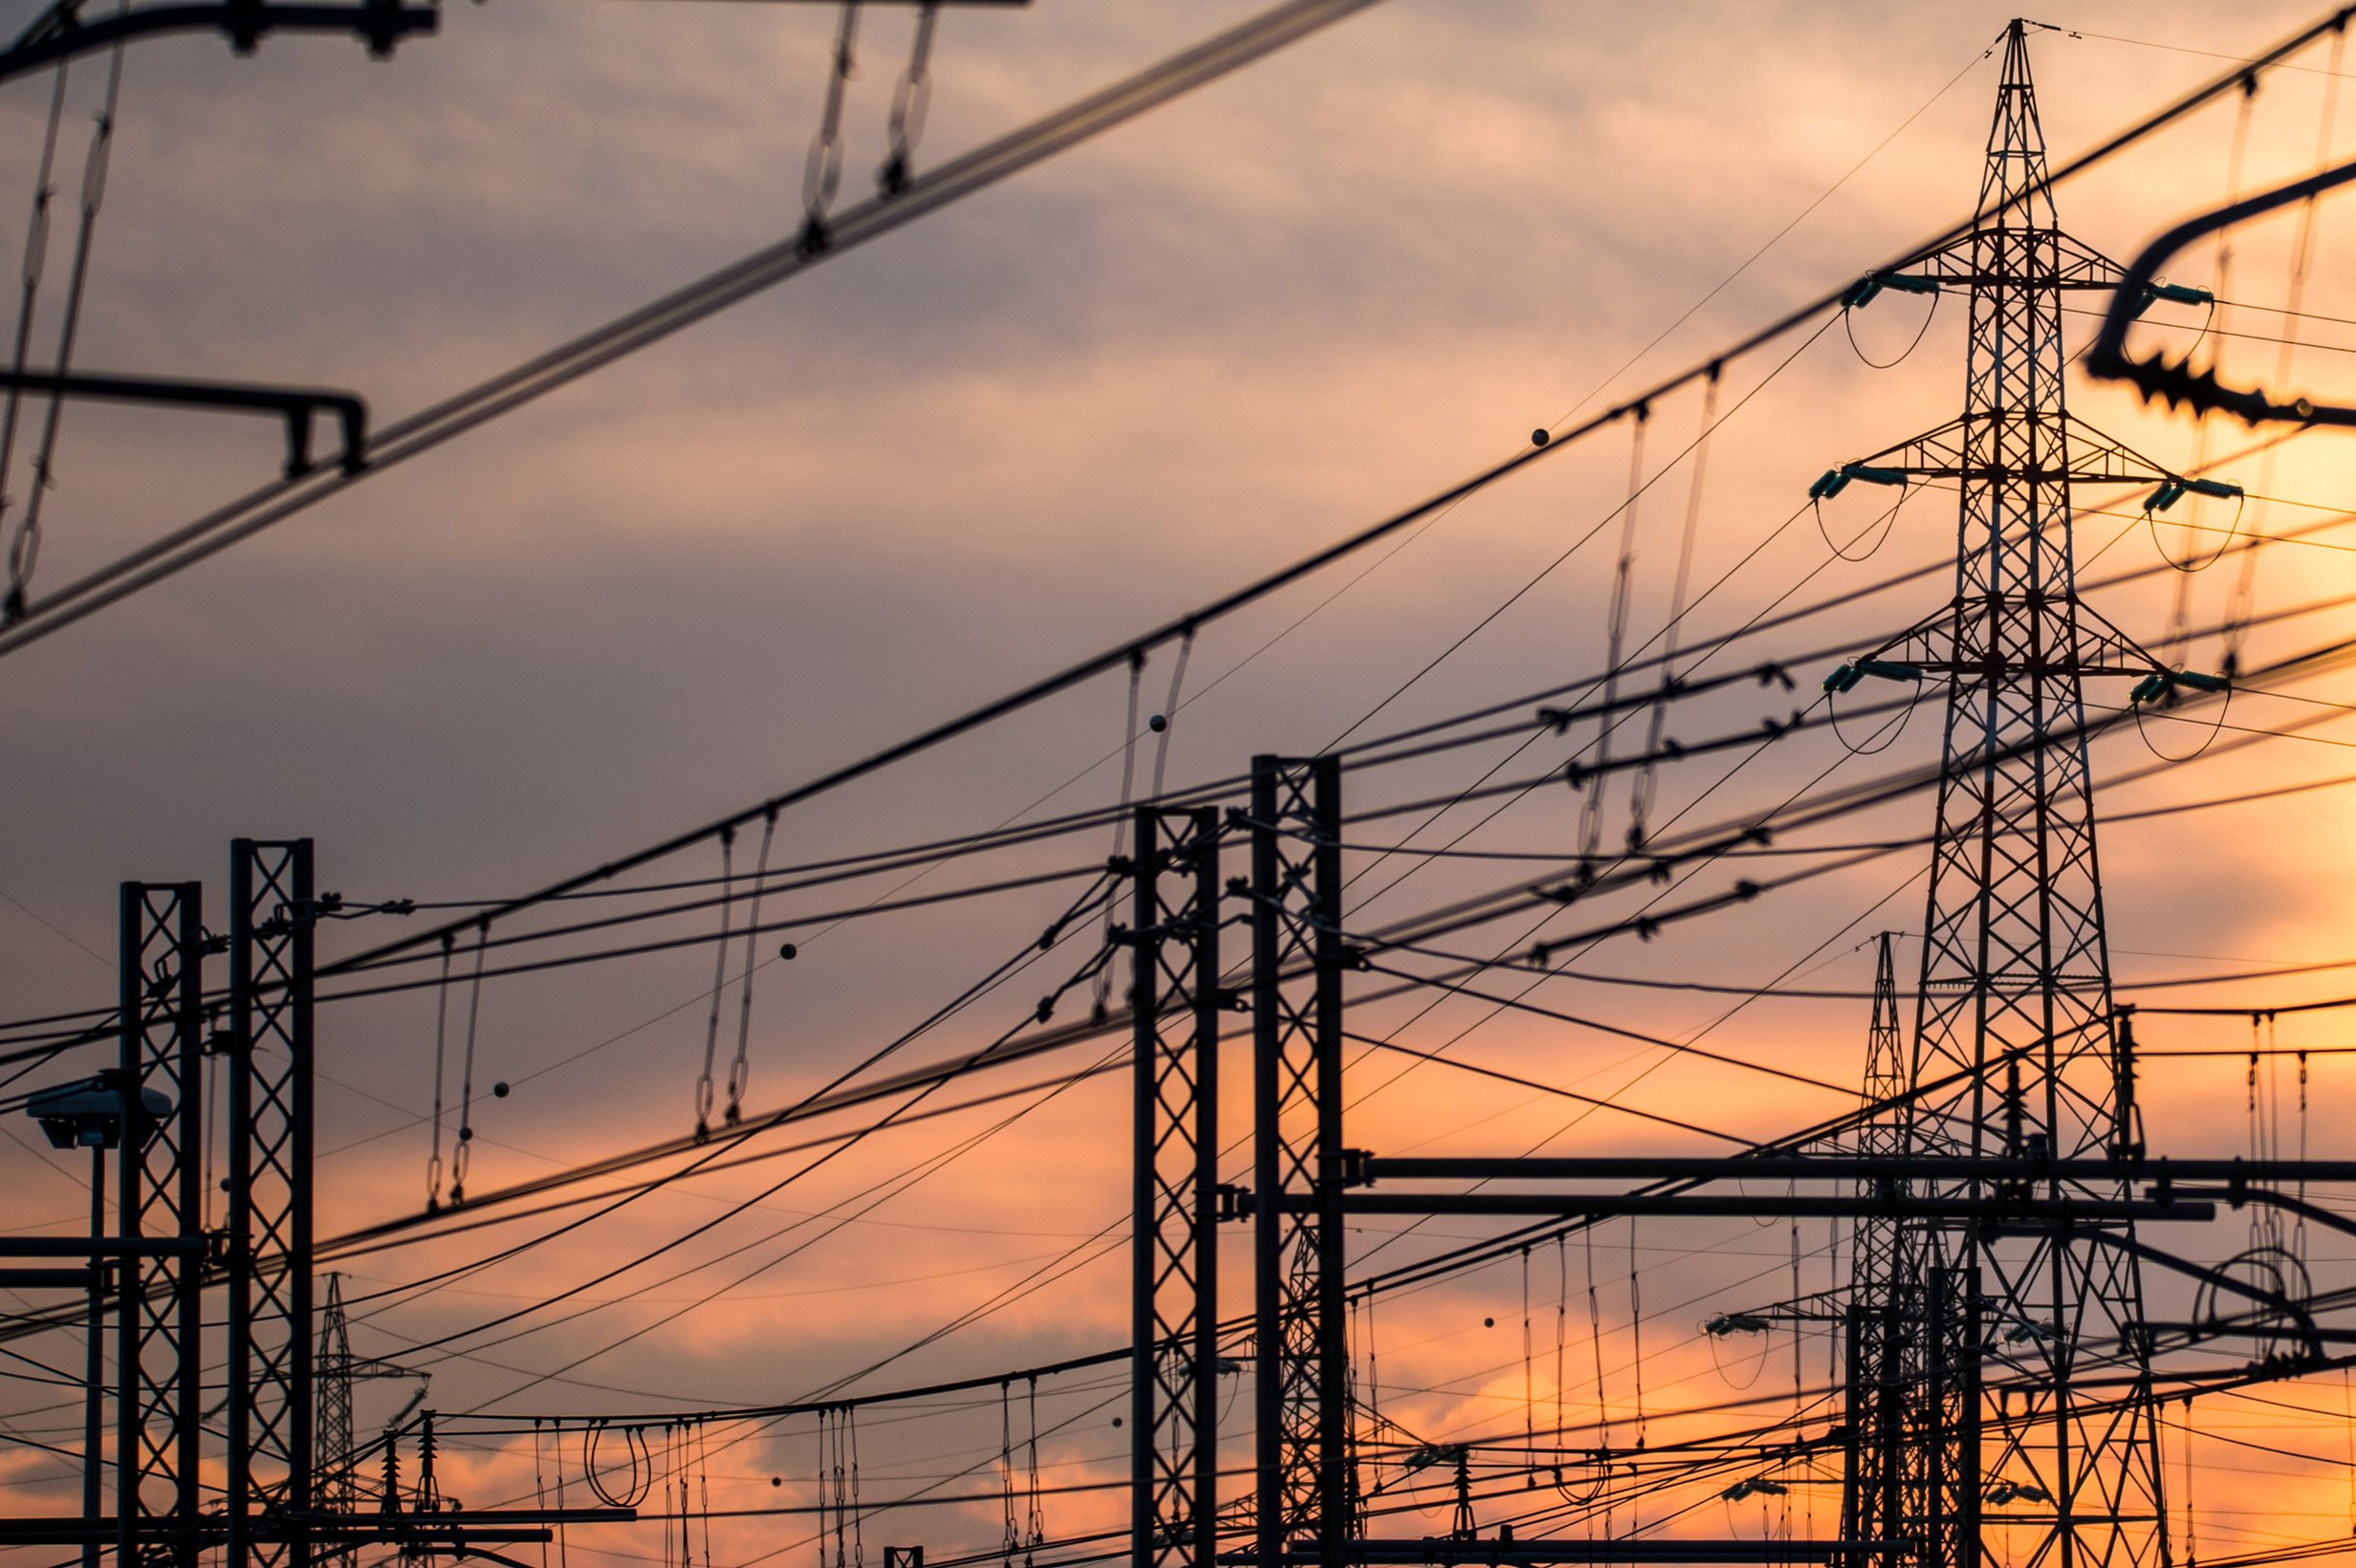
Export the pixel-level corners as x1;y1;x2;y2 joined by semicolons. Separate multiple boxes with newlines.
1817;21;2195;1568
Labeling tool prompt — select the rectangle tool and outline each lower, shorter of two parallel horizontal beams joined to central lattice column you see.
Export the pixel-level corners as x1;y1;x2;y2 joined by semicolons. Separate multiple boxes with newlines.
1281;1187;2217;1224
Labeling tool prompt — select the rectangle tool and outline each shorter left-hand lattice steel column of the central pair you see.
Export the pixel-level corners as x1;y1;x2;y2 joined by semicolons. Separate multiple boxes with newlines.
1126;805;1220;1568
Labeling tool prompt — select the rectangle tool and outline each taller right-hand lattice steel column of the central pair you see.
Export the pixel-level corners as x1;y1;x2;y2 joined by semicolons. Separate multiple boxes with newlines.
1249;755;1355;1568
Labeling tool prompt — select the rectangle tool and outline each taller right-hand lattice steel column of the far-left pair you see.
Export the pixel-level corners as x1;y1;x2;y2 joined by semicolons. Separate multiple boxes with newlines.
227;838;316;1568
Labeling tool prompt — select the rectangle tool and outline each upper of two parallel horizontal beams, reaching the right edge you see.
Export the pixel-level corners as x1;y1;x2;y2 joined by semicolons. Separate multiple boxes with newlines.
1364;1154;2356;1182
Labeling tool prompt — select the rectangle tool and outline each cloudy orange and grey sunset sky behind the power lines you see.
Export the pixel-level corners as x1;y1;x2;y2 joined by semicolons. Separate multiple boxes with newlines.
0;0;2356;1561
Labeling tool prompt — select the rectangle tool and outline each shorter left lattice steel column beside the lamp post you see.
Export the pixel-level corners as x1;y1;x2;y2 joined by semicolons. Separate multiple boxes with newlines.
116;882;205;1568
